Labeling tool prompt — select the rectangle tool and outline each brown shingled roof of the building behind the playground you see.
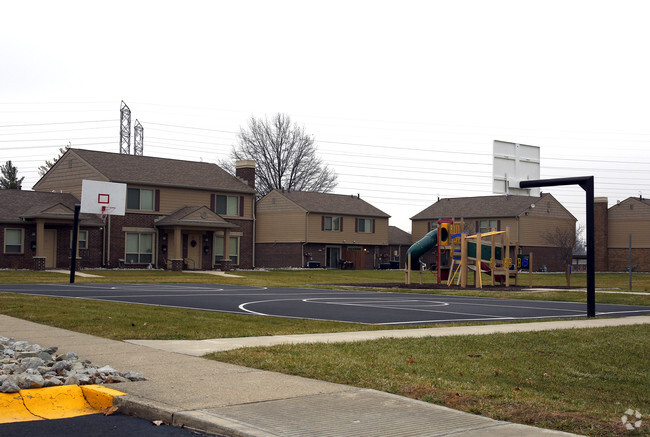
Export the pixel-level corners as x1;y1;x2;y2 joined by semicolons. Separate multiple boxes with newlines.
411;193;573;220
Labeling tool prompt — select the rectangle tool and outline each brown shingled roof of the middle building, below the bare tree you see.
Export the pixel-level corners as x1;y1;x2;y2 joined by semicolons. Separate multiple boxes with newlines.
273;190;390;218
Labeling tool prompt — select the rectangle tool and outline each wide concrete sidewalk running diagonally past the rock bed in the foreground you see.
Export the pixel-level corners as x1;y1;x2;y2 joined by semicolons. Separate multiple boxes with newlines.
6;315;650;437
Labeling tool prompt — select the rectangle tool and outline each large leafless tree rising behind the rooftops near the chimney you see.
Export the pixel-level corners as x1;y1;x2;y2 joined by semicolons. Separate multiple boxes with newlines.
219;114;337;196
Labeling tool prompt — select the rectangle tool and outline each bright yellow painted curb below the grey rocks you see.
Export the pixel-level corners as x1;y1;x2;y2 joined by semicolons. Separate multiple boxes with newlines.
0;385;126;423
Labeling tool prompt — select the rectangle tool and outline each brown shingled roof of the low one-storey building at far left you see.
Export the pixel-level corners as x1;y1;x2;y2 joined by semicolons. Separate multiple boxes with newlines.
0;190;102;226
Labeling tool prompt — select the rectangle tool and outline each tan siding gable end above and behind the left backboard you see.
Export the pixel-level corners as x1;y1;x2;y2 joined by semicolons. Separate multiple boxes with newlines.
34;153;108;196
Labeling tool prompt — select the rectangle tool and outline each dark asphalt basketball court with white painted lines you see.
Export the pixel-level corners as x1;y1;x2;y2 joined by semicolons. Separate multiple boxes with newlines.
0;284;650;325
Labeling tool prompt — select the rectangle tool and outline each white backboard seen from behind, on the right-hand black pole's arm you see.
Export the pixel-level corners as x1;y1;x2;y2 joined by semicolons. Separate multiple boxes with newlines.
492;140;540;196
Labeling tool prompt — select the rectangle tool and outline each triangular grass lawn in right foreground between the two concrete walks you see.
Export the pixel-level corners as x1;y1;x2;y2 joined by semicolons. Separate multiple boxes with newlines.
209;325;650;436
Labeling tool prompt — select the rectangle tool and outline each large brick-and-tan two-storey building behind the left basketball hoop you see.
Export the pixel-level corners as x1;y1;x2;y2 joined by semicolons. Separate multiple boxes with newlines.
29;149;255;270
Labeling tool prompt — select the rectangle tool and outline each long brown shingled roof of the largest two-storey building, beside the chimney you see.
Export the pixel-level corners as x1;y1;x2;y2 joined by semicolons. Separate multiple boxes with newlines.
57;149;255;194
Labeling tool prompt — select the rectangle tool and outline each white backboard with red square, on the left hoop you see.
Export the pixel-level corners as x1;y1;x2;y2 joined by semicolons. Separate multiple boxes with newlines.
81;179;126;215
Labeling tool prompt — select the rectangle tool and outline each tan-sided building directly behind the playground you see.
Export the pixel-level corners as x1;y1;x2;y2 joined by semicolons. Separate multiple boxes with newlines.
411;194;576;271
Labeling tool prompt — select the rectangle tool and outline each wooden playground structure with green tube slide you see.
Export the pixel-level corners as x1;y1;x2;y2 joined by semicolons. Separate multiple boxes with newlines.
405;219;533;288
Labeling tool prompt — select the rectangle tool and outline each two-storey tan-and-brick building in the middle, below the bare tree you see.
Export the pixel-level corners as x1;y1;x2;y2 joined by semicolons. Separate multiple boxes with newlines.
255;190;389;269
